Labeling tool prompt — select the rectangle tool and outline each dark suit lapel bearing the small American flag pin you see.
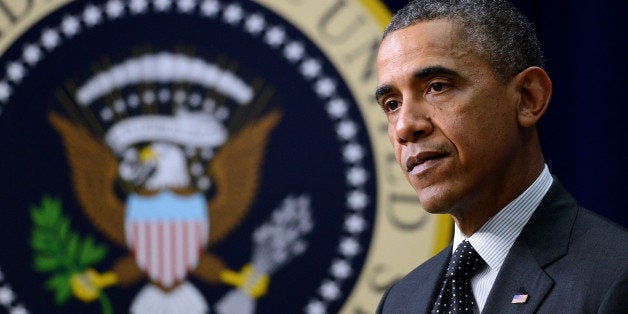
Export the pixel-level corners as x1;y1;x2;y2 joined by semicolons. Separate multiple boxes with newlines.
484;179;576;313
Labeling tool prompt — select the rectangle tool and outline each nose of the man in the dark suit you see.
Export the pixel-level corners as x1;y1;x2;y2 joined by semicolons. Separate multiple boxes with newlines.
394;101;434;144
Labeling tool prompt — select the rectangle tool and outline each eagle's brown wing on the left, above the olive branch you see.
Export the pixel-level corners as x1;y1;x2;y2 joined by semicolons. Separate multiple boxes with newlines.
48;112;126;246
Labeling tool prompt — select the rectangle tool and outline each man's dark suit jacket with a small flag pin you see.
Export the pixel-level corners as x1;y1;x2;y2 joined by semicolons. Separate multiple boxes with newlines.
377;179;628;314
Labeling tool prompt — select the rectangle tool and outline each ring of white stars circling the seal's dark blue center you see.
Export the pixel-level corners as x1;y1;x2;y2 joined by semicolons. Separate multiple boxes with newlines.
0;0;371;314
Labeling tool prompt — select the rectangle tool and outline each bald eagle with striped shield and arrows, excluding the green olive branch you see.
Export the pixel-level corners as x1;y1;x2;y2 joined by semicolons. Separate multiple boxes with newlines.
48;52;313;313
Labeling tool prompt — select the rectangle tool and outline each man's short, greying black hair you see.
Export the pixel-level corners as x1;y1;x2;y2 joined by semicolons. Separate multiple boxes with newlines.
383;0;544;82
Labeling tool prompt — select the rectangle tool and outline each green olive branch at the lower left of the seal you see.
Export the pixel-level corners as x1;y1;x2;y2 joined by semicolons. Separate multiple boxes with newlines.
30;195;112;313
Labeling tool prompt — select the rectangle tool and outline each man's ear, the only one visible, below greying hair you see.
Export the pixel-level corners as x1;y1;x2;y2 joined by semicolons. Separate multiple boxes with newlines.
515;67;552;127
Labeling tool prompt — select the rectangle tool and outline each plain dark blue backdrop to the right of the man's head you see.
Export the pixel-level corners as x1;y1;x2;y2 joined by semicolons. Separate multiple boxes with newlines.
384;0;628;226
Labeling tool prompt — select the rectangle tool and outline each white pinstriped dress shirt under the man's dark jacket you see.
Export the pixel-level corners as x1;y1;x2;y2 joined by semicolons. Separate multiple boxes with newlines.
452;165;554;313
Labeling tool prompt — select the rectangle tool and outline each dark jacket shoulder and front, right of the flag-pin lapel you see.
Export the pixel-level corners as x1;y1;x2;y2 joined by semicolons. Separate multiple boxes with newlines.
544;207;628;312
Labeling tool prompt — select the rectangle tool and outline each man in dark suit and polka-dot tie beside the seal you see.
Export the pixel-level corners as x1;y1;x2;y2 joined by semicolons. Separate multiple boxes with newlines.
376;0;628;313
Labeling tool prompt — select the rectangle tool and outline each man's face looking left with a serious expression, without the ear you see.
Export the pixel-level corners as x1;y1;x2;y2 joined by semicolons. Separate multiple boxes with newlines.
376;20;522;214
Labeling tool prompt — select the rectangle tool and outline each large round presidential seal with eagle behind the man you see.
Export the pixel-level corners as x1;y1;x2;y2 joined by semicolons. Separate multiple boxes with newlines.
0;0;450;314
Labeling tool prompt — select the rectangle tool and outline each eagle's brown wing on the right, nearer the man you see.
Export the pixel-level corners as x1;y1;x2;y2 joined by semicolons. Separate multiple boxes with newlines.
208;111;281;245
